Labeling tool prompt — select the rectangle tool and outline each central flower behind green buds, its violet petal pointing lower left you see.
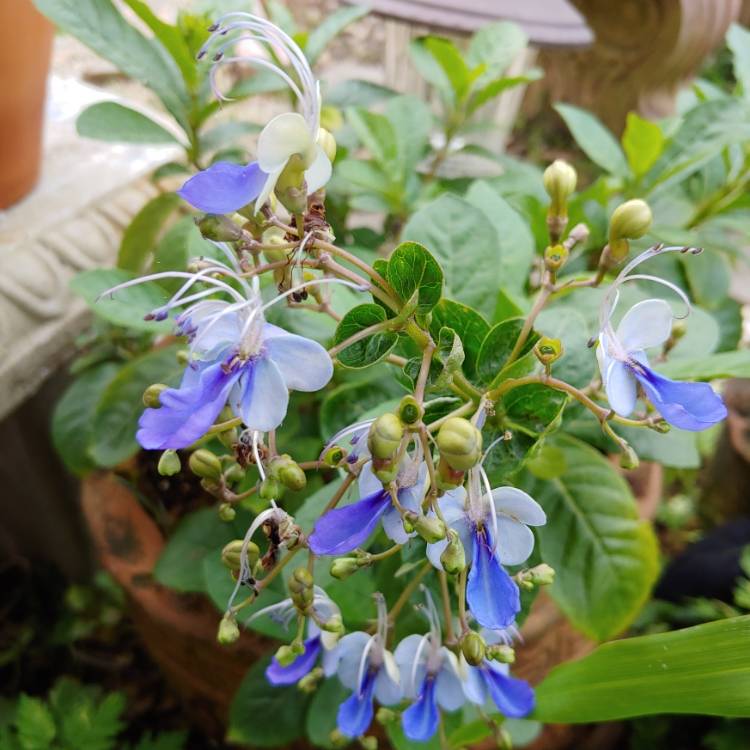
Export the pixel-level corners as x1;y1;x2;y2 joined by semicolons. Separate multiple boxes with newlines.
308;455;427;555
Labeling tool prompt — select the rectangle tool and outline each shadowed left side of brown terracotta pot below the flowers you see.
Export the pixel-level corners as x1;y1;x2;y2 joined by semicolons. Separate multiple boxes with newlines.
82;474;273;738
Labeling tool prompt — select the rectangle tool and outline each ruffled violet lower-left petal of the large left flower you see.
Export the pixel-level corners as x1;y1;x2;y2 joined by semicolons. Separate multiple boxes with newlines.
136;361;242;450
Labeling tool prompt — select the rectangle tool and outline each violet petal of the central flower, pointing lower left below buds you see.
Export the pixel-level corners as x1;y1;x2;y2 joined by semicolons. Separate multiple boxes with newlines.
307;490;391;555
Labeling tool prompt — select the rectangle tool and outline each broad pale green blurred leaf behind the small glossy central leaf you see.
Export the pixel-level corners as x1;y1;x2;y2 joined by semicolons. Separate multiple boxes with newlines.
402;195;501;317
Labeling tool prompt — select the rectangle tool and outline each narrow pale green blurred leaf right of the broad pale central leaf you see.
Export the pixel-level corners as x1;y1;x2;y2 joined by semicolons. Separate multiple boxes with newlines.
466;180;535;292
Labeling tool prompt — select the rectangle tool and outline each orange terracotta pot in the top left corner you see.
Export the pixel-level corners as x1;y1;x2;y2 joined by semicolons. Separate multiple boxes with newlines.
0;0;54;208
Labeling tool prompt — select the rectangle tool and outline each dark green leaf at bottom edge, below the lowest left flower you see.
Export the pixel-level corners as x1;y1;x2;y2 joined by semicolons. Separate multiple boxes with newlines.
227;656;309;747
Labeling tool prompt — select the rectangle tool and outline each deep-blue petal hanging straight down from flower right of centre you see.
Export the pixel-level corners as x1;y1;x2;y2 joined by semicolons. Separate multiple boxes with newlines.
466;528;521;630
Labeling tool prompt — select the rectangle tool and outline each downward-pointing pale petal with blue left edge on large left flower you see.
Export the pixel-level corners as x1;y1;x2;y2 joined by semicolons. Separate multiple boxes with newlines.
236;357;289;432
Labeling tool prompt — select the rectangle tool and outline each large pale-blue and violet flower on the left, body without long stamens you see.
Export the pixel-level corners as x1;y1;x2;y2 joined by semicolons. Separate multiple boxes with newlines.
136;299;333;449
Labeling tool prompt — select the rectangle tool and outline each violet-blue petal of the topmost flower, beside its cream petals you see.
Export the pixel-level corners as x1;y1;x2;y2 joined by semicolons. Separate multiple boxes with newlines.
177;161;268;214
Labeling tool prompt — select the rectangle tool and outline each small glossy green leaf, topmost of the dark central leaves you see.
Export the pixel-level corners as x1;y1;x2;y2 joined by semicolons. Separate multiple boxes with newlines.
388;242;443;315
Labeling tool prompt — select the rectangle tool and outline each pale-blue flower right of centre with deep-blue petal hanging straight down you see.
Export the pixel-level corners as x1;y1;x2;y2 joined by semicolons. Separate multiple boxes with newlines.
427;476;547;630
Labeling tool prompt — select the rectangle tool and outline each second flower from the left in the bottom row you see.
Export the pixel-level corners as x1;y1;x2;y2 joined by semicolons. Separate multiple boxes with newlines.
337;596;402;737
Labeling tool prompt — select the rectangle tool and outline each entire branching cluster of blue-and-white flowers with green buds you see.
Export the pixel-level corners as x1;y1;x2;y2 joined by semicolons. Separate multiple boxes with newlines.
95;13;726;741
